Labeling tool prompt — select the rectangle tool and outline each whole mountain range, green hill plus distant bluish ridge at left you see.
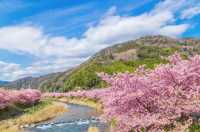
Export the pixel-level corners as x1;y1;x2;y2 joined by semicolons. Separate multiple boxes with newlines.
3;35;200;91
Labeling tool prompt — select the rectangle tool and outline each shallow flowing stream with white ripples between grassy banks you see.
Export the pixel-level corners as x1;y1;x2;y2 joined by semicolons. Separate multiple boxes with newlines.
25;104;108;132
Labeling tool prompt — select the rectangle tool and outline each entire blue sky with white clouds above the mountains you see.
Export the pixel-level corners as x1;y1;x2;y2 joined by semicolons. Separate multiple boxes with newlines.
0;0;200;81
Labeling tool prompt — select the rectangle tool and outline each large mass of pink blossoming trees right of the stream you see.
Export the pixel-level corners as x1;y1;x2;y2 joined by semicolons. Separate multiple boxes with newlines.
44;53;200;132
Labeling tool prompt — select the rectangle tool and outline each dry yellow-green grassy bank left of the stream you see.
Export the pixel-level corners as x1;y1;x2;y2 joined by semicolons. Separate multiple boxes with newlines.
0;101;67;132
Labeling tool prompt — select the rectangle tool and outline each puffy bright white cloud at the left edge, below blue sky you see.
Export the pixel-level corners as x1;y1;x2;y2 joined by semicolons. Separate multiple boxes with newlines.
0;26;46;55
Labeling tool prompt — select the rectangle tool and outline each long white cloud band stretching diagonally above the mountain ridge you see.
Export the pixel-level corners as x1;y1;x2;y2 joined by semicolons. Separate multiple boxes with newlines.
0;0;194;80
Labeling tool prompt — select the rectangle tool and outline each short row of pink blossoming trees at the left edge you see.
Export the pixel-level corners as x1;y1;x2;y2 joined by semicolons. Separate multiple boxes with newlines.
0;89;41;110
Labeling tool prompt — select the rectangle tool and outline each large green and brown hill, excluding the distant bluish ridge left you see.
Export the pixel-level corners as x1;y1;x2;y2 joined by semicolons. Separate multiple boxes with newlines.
41;36;198;91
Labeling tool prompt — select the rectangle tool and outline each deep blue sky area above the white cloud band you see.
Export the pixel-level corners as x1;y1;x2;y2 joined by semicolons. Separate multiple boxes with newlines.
0;0;159;37
